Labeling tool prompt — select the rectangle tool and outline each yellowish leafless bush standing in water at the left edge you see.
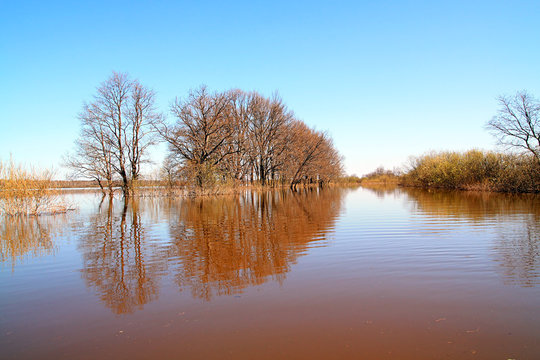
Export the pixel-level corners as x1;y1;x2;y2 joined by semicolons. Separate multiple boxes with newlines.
0;160;67;215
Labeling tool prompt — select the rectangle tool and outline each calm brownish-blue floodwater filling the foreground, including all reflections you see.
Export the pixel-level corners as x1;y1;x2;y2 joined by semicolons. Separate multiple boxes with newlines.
0;188;540;359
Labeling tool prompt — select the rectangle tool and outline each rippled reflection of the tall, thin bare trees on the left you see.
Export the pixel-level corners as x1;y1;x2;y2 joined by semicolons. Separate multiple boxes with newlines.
80;198;167;314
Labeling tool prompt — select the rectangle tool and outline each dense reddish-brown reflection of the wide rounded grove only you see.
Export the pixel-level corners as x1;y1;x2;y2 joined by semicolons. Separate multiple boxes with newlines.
169;189;344;300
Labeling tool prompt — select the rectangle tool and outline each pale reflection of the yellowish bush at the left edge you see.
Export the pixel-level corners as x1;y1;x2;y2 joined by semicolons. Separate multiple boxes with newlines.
0;215;67;269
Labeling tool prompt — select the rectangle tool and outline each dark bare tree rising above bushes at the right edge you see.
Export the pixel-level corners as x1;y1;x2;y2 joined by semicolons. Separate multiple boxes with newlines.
487;91;540;163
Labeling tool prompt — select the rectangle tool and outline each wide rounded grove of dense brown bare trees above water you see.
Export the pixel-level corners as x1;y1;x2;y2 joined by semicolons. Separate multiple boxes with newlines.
157;87;342;187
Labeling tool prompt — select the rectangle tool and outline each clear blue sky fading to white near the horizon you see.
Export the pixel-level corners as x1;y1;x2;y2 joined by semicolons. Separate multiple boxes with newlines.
0;0;540;175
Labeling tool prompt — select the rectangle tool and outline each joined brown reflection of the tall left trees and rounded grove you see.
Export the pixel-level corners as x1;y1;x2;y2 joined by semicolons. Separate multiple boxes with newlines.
79;189;347;314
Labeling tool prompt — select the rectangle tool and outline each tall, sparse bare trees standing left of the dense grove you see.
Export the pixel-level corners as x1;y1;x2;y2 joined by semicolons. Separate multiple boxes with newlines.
65;73;161;195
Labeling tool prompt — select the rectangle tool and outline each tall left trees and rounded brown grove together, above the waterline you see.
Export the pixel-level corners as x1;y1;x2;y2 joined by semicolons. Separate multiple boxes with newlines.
65;73;343;196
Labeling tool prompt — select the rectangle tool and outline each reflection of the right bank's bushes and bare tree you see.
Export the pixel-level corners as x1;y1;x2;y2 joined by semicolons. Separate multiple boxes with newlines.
399;189;540;287
